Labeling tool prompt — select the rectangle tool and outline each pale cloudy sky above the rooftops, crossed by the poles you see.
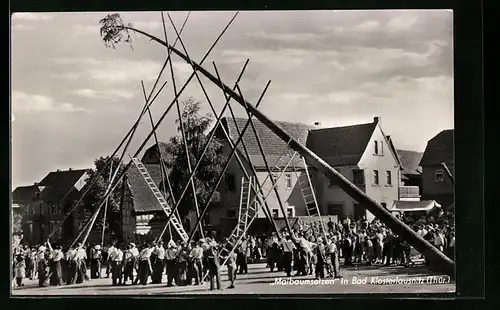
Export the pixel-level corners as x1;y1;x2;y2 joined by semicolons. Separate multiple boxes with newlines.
11;10;454;189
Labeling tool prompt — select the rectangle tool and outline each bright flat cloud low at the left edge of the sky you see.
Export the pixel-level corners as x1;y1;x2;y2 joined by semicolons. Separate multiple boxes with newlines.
12;91;92;113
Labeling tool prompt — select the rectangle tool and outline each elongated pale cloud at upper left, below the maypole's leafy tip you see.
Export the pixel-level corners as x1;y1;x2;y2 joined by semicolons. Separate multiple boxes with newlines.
53;57;162;84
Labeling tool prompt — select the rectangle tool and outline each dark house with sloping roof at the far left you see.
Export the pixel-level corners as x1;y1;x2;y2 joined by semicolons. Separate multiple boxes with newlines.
12;169;88;244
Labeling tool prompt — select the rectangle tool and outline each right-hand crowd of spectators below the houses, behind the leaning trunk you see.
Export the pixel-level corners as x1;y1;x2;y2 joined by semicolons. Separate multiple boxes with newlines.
232;213;455;278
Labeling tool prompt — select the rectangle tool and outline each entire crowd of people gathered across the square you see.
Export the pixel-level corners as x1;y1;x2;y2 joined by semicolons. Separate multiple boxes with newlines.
13;209;455;289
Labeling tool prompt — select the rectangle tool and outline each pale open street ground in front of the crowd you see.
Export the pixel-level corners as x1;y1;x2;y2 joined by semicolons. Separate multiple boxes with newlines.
13;264;455;296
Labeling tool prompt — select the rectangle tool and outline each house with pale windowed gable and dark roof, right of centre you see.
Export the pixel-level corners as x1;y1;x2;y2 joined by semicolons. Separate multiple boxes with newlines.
308;118;401;221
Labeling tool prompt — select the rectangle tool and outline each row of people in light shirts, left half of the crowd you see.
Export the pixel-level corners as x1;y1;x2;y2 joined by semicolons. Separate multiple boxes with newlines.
13;238;227;289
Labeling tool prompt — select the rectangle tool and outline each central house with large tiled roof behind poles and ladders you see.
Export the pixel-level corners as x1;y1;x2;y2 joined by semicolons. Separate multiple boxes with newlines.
210;118;309;226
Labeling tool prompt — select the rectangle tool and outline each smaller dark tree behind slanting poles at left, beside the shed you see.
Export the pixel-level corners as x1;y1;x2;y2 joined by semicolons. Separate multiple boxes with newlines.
80;156;125;241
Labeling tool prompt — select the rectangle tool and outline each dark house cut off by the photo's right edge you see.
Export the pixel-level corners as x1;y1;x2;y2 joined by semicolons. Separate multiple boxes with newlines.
420;129;455;209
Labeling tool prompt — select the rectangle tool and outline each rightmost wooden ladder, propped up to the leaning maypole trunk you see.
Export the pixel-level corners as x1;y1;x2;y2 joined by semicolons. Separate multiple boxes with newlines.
293;157;326;237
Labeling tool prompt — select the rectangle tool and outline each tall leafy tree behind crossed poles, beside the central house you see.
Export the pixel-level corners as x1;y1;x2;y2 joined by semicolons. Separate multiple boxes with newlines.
166;98;225;218
